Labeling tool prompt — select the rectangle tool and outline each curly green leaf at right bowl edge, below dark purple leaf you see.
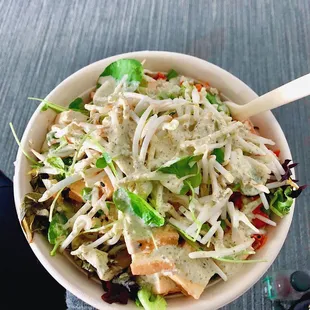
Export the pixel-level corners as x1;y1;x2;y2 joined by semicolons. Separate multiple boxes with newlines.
268;186;294;217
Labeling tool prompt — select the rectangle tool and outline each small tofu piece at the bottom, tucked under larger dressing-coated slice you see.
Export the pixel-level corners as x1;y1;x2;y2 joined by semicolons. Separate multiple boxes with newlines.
138;273;181;295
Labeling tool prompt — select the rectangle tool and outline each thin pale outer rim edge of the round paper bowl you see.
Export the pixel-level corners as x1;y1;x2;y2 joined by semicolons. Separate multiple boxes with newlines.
13;50;295;309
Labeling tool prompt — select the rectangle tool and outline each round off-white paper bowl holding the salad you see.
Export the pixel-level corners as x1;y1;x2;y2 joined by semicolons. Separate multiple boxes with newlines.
14;51;294;310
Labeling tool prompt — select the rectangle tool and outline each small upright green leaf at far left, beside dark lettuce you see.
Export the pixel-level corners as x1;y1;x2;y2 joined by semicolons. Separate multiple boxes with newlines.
47;213;68;256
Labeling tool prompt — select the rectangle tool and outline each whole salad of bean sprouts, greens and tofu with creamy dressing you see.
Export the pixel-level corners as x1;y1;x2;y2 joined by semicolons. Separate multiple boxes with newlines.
11;59;304;310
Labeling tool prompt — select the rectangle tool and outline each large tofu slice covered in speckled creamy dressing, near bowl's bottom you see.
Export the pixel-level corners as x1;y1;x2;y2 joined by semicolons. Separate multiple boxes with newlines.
131;245;215;299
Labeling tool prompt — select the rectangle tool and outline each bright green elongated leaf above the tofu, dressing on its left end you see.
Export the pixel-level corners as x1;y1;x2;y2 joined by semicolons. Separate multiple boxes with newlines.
113;187;165;227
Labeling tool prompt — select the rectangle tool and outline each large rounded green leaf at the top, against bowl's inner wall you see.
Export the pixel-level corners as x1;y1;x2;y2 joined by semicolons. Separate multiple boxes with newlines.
100;59;143;82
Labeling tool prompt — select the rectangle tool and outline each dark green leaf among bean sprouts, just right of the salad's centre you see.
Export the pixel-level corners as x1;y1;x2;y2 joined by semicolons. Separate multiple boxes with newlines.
157;155;202;195
